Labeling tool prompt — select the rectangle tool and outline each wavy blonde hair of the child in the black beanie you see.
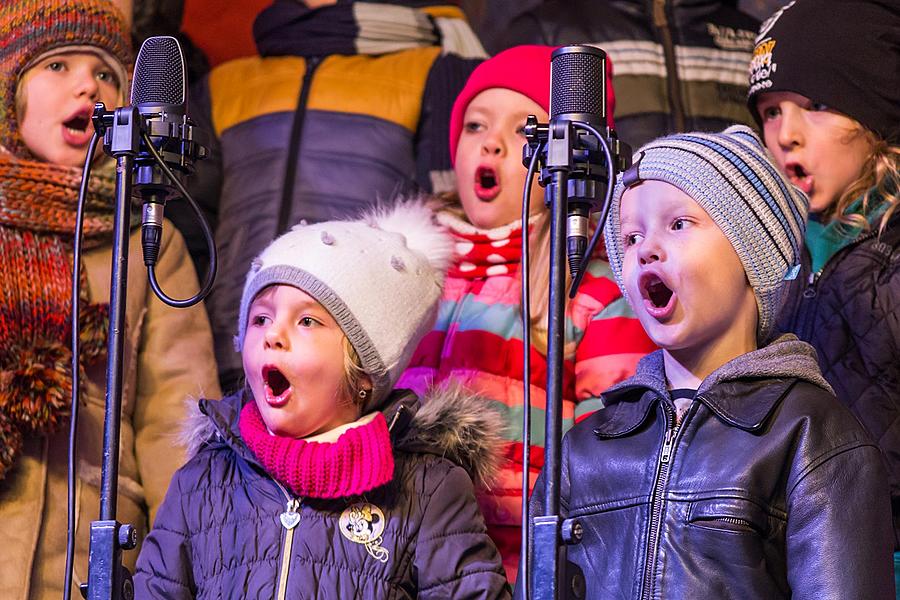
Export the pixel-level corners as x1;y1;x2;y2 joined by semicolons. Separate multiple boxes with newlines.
827;125;900;235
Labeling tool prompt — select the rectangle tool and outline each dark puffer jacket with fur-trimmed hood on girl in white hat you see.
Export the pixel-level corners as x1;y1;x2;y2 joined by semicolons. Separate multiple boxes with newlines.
135;390;510;600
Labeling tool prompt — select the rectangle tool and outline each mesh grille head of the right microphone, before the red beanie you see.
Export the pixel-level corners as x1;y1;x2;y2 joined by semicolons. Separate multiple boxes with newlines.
550;45;606;123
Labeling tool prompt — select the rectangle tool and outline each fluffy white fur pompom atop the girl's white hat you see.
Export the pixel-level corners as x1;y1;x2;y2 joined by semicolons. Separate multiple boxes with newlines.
363;199;453;271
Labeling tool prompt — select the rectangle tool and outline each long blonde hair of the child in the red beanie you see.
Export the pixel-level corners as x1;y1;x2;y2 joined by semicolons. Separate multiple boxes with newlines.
432;192;572;354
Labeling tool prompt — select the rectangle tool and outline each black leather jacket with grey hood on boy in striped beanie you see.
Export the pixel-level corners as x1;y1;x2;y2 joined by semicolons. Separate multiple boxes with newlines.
520;335;894;600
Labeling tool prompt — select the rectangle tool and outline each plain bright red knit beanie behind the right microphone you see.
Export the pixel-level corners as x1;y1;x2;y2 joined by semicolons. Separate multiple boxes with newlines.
450;46;616;164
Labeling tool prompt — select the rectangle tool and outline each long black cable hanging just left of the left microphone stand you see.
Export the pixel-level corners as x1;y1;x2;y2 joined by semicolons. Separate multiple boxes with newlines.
63;131;100;600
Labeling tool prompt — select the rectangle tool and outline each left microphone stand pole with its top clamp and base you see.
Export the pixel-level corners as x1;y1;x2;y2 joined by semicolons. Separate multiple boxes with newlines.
81;104;141;600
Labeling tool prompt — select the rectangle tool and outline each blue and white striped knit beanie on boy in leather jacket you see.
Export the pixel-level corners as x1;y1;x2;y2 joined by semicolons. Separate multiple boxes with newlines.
604;125;809;343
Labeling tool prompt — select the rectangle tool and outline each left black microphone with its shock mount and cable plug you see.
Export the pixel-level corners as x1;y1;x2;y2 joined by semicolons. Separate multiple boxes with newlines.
131;36;209;266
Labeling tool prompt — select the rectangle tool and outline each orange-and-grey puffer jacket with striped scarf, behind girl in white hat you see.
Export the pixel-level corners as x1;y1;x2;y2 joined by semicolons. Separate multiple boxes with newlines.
187;0;488;393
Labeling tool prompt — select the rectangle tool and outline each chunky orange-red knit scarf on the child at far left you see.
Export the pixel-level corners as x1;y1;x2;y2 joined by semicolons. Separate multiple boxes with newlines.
0;155;121;480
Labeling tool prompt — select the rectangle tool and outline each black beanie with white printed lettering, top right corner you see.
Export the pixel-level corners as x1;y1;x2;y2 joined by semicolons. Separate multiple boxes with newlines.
748;0;900;144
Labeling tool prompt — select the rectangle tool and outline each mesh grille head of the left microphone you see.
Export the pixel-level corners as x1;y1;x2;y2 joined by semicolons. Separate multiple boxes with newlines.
131;36;187;106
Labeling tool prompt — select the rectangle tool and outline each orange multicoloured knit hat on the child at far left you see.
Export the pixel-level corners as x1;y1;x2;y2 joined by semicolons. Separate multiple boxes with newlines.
0;0;132;158
